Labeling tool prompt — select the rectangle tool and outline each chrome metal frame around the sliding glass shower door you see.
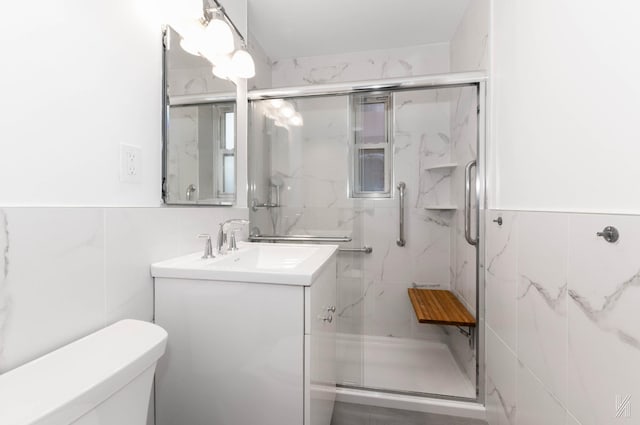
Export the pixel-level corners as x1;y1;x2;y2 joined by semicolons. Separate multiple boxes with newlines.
244;72;488;405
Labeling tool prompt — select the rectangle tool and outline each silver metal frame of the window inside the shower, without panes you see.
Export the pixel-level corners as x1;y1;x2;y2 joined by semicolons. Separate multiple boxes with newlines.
349;92;393;199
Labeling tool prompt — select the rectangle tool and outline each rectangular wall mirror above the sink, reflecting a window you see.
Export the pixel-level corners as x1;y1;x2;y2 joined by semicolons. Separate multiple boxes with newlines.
162;27;236;205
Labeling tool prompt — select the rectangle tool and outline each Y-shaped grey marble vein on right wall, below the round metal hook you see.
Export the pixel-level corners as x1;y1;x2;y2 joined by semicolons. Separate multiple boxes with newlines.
569;271;640;350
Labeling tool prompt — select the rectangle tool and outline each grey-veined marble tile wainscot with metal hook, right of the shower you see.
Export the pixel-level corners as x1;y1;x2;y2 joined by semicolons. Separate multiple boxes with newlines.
486;211;640;425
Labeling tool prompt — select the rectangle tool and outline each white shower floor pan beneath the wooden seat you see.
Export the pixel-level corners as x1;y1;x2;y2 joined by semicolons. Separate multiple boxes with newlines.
338;335;476;398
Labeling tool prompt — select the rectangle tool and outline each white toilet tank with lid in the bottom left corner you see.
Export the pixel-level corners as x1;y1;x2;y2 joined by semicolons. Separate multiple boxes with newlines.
0;320;167;425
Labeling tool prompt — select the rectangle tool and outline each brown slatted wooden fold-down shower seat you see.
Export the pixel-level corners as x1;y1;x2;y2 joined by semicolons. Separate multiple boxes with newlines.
409;288;476;328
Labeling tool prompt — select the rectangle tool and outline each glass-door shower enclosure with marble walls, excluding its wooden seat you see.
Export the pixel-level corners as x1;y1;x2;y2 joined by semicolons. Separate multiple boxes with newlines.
249;74;484;402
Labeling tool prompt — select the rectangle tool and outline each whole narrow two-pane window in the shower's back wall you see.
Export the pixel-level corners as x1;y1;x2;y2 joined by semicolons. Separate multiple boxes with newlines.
350;93;392;198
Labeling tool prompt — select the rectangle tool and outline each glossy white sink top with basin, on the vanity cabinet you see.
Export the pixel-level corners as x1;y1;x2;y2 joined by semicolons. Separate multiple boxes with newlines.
151;243;338;286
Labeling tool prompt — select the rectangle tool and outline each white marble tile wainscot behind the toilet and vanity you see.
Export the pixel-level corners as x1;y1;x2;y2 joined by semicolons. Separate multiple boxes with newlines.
0;207;248;373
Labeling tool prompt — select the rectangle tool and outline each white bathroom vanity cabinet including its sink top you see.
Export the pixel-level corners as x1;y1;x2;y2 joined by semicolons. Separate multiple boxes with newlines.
151;243;337;425
